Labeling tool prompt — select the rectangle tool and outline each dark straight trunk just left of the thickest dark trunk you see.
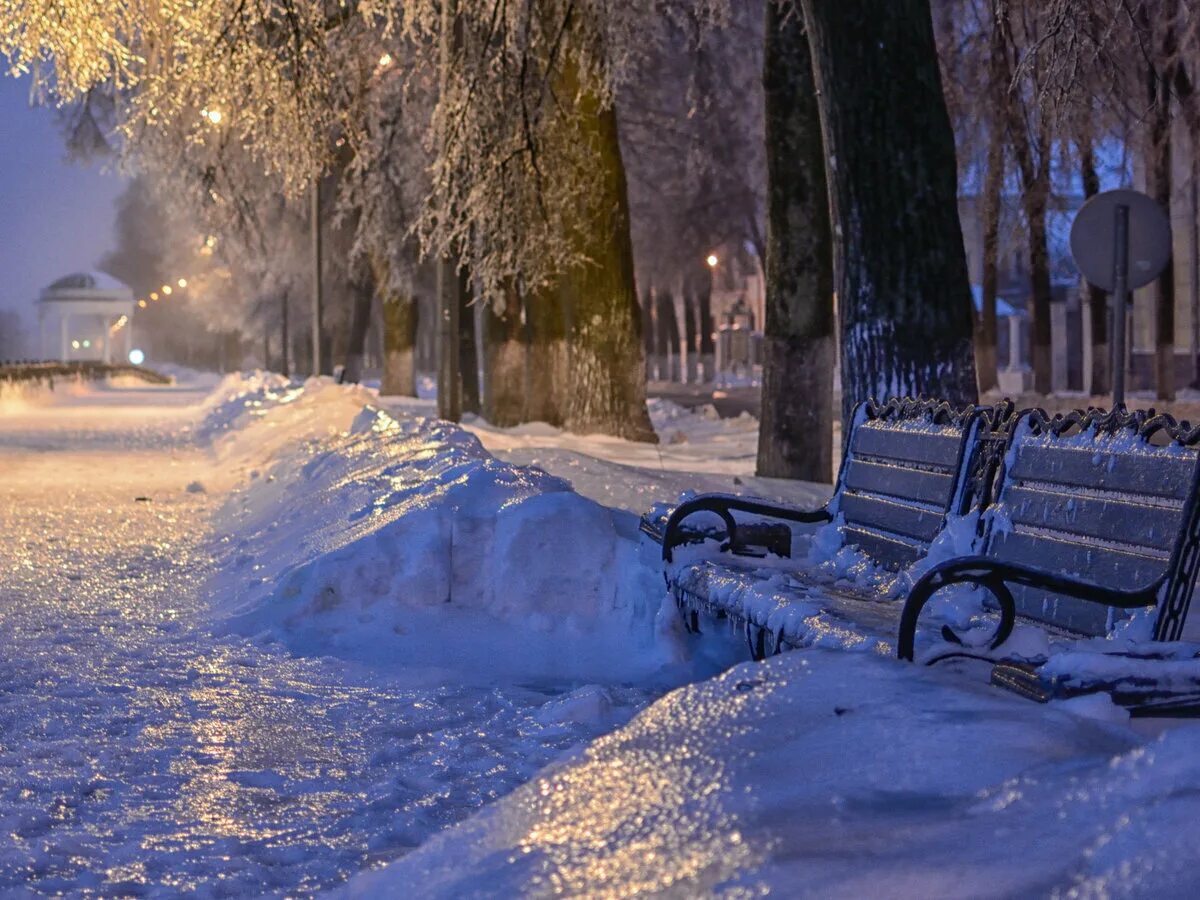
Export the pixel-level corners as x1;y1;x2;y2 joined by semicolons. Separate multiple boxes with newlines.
757;2;836;481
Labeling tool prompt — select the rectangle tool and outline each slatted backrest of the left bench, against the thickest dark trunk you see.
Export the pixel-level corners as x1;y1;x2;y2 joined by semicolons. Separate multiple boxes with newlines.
830;398;1012;569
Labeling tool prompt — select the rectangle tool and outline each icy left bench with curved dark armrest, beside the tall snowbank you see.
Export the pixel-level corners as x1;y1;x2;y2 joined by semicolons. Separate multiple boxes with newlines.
642;398;1012;659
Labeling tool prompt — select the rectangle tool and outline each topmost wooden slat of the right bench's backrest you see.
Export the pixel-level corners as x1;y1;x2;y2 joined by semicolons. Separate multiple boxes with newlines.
1010;439;1196;500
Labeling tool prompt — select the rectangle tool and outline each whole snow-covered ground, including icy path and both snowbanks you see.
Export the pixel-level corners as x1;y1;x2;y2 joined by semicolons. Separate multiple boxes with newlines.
7;377;1200;898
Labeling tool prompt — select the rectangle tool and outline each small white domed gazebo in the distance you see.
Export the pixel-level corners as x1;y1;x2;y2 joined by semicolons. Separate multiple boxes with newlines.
37;272;133;362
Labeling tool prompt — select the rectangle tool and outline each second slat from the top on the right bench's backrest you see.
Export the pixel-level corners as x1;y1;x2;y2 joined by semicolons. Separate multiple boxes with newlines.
1001;486;1183;552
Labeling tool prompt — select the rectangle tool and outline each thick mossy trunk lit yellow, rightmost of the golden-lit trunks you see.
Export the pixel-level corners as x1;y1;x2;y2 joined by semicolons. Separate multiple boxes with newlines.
562;54;658;442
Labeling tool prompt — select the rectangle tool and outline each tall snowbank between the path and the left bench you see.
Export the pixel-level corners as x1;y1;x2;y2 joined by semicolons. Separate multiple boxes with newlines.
202;373;670;682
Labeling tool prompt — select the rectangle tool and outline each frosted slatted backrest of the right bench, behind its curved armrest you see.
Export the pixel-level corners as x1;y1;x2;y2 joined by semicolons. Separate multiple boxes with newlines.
984;408;1200;640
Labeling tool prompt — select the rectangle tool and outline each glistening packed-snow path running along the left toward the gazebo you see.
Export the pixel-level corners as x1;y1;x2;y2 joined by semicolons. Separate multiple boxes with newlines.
0;389;649;895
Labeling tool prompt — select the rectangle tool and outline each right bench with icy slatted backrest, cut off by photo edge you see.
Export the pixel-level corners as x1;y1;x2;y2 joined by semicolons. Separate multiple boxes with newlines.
896;408;1200;706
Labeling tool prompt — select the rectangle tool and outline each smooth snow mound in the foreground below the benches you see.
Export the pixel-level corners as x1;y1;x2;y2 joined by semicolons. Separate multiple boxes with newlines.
343;650;1200;898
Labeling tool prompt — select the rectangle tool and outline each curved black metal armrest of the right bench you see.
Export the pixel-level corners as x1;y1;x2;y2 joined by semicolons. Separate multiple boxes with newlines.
896;557;1160;661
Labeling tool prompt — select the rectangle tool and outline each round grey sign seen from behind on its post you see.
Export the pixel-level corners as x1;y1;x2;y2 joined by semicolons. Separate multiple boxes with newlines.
1070;191;1171;407
